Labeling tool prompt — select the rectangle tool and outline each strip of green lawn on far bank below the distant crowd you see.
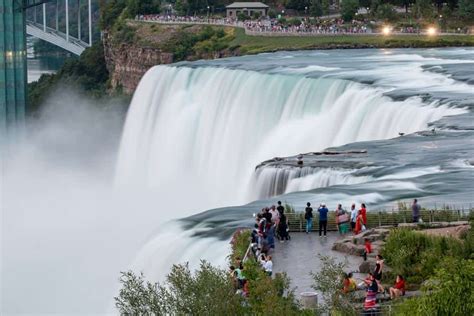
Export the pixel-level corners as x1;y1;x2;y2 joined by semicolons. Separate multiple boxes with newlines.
231;28;474;54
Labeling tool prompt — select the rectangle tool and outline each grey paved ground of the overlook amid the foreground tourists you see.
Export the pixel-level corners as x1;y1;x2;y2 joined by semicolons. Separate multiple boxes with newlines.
273;232;362;296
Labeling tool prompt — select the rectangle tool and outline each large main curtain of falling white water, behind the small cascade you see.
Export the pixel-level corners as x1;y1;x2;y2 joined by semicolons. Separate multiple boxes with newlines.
116;66;464;211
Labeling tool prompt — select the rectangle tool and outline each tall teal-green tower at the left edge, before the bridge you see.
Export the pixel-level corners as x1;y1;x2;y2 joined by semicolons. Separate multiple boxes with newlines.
0;0;28;137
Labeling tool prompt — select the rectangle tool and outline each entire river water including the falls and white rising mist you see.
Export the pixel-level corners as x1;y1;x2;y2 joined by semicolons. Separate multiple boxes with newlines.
2;48;474;314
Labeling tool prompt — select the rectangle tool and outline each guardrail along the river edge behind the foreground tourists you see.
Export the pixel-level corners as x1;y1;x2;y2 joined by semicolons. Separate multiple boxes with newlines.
285;208;474;232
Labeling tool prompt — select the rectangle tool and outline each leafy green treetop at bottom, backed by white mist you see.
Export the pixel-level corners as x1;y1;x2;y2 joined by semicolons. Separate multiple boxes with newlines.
115;261;242;315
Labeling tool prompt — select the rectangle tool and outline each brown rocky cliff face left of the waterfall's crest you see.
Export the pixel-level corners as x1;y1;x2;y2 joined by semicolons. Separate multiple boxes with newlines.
103;33;173;94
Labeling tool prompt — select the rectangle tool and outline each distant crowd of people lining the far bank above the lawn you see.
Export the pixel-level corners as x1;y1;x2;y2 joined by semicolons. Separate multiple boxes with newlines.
135;14;371;34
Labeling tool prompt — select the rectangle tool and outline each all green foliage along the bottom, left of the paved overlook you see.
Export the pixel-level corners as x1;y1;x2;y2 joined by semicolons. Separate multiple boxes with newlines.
115;261;302;316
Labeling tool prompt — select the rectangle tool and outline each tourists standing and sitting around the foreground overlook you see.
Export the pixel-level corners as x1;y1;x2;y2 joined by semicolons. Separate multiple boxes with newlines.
230;199;421;311
